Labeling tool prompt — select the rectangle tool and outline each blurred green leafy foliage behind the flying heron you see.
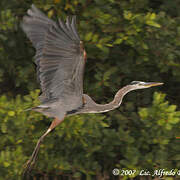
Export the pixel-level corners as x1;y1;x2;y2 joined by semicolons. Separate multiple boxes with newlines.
0;0;180;180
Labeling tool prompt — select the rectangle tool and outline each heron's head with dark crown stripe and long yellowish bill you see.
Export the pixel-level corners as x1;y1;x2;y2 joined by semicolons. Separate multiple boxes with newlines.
130;81;163;89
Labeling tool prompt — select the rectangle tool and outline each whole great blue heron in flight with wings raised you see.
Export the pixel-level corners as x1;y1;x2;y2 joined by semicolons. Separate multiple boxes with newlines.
22;5;163;175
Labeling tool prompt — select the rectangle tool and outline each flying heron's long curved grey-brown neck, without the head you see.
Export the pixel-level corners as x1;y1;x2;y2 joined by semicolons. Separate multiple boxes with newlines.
82;85;134;113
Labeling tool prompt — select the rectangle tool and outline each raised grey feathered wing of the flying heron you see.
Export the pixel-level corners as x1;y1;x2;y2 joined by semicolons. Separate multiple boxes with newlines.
22;5;85;107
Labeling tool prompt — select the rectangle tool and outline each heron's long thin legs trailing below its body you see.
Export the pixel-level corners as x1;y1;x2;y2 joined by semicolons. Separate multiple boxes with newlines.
23;118;64;176
